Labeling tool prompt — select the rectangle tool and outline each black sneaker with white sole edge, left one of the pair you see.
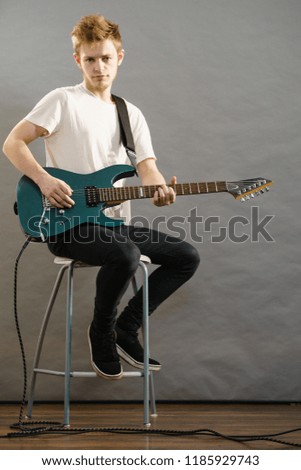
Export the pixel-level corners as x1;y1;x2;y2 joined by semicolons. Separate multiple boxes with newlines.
88;326;123;380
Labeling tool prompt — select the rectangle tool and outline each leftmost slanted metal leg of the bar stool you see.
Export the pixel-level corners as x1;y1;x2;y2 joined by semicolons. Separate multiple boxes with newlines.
27;265;68;418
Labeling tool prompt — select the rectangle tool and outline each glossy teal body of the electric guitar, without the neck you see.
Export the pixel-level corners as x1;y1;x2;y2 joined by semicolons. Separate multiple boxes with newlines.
17;165;135;241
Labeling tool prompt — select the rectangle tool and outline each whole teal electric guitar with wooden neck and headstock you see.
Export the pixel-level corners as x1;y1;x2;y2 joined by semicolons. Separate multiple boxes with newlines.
17;165;272;241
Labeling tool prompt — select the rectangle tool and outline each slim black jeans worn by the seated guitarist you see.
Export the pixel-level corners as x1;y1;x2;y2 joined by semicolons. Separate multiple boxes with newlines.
48;224;200;333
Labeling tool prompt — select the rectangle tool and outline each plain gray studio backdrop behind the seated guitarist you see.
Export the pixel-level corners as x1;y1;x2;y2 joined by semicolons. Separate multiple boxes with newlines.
0;0;301;401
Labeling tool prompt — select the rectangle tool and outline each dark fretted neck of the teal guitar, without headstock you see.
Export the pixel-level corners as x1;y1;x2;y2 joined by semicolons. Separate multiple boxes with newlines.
94;181;228;202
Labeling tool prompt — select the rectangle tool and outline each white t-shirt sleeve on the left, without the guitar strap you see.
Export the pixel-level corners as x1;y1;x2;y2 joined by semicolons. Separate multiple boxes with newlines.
25;89;66;135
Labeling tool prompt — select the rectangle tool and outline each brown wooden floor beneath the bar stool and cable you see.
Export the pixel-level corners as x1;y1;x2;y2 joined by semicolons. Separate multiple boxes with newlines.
0;403;301;450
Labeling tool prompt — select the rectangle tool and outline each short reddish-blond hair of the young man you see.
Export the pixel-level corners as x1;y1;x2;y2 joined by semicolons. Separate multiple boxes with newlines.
71;15;122;55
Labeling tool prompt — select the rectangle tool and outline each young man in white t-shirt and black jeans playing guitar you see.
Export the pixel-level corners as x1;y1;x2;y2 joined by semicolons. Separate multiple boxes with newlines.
3;15;199;379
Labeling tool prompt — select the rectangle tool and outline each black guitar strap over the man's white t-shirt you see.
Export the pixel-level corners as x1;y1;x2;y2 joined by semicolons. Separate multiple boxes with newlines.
112;95;138;176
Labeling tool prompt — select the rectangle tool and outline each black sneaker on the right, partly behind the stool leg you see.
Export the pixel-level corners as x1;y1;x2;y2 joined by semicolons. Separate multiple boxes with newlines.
116;325;161;371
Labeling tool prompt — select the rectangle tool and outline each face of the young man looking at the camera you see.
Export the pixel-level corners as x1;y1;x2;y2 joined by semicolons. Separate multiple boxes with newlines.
74;39;124;93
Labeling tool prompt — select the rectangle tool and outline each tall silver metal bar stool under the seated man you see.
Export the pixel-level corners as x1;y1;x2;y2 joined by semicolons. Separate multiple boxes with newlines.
27;255;157;427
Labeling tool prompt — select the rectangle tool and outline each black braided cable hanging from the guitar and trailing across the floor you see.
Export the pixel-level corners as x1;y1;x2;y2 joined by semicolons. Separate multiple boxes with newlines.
0;236;301;448
